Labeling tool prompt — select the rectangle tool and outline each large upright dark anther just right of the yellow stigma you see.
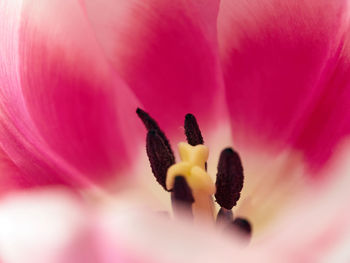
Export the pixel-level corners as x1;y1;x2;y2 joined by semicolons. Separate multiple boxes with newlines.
215;148;244;210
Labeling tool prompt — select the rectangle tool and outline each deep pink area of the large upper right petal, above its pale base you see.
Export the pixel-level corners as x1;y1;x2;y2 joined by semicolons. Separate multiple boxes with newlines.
218;0;350;172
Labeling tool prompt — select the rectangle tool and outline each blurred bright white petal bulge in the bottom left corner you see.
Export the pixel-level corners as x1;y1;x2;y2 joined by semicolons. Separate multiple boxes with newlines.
0;189;88;263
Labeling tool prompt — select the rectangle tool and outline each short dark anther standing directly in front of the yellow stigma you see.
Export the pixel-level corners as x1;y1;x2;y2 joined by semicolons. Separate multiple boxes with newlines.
171;175;194;219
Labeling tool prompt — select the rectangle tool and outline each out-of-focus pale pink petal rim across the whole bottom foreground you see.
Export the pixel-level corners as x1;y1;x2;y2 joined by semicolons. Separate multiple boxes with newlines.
0;141;350;263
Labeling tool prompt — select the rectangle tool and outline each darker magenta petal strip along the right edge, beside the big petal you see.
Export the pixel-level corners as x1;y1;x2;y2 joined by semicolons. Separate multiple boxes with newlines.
296;34;350;169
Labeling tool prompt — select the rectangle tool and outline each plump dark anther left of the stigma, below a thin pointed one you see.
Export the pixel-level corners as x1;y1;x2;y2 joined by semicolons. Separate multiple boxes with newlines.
146;130;175;190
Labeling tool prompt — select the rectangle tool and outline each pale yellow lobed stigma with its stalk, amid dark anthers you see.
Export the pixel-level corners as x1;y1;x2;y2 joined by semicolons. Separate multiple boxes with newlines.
166;142;215;223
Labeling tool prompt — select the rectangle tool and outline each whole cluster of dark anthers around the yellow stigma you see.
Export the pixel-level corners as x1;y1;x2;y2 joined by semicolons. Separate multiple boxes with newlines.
136;108;252;242
